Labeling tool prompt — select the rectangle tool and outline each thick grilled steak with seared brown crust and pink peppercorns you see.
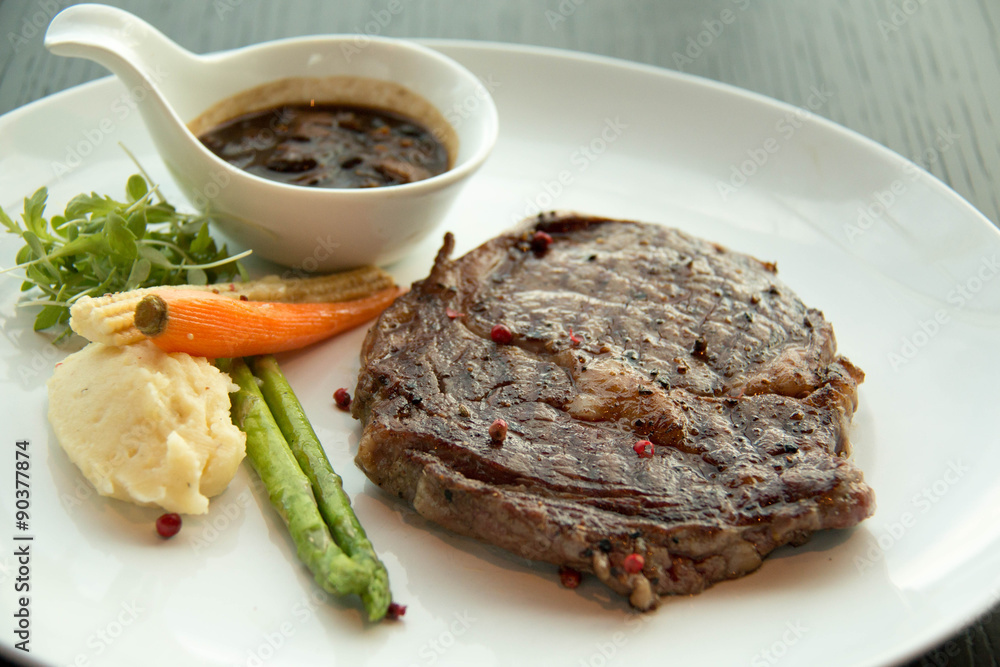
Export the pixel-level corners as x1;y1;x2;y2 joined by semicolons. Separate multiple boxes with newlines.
353;214;874;609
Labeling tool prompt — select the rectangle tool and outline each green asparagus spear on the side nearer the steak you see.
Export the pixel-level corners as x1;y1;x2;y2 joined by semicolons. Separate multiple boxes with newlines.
250;355;392;621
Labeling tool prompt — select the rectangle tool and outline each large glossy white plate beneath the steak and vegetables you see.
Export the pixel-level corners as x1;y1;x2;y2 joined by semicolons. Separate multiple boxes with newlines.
0;42;1000;667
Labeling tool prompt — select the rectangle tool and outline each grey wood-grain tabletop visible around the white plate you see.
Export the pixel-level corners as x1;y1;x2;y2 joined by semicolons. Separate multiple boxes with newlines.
0;0;1000;667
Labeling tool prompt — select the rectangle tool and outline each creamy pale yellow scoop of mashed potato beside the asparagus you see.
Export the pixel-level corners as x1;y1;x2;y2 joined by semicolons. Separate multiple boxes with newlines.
48;342;246;514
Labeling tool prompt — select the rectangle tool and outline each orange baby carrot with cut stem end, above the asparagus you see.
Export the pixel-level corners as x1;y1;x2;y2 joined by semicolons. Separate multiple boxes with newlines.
135;287;400;359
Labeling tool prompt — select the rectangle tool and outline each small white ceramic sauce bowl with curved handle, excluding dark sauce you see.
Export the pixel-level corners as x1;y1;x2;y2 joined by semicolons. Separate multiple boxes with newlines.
45;4;498;271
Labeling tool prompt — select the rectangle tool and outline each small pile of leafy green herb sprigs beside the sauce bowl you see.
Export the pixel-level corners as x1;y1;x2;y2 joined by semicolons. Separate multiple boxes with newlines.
0;174;249;340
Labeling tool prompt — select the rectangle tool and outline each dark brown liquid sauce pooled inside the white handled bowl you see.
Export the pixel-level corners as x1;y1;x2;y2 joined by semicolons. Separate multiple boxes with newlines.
198;104;449;188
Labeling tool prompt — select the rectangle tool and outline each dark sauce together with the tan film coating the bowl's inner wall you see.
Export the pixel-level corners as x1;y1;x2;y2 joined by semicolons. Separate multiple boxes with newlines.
188;76;458;189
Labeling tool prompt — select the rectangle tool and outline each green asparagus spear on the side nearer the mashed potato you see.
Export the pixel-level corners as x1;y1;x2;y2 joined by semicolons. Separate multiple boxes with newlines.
216;359;372;595
